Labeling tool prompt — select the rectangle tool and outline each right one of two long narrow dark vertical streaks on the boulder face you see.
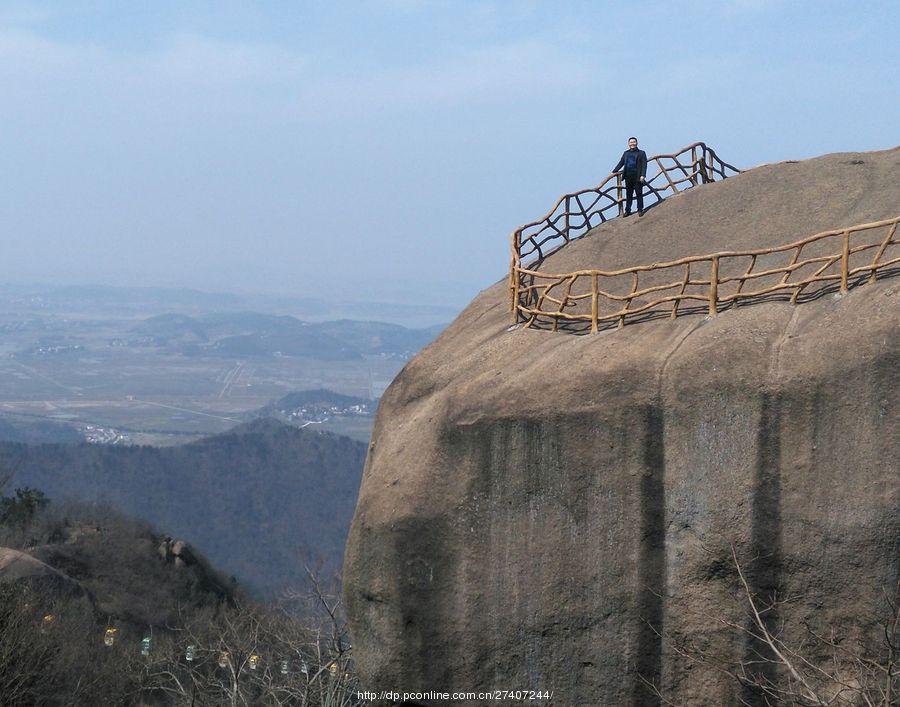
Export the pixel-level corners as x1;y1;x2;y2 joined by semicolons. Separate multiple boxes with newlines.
742;393;781;705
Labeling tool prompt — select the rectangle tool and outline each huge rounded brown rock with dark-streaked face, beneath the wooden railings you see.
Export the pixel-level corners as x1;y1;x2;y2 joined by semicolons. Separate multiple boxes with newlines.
345;149;900;705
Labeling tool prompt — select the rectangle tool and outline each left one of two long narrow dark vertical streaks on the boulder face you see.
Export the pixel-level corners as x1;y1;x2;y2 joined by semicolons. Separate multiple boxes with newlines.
632;405;666;705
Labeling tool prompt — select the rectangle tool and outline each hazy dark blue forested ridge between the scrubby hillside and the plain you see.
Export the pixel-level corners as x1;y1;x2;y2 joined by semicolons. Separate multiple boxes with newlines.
0;419;366;593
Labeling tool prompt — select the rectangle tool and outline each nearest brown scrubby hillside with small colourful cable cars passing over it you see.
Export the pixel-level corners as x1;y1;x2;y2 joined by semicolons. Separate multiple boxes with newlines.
0;496;357;707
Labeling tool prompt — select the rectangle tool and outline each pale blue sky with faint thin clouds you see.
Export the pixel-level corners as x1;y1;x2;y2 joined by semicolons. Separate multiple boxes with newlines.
0;0;900;306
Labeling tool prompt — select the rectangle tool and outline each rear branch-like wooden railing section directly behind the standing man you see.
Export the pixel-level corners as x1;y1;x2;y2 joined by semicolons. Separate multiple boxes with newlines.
509;142;740;318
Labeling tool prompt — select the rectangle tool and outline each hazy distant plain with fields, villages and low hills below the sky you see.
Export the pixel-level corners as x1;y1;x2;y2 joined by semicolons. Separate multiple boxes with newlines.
0;285;452;445
